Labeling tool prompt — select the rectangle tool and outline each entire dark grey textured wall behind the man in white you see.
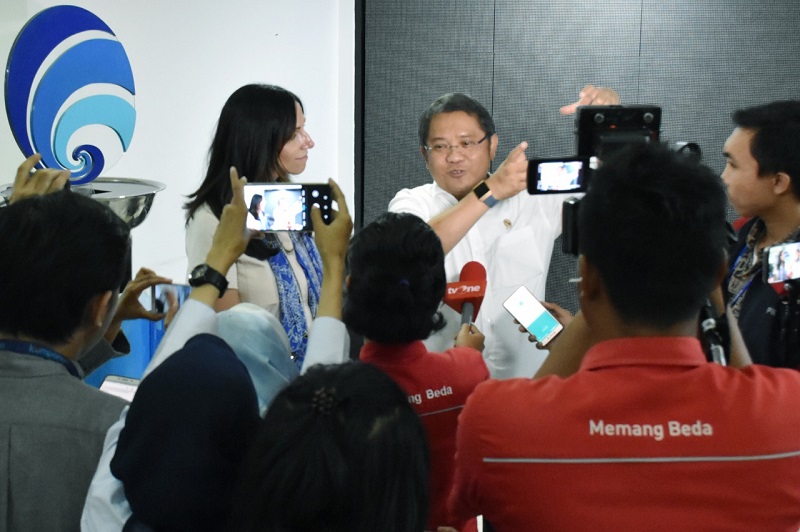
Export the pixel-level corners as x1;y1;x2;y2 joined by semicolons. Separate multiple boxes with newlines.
363;0;800;310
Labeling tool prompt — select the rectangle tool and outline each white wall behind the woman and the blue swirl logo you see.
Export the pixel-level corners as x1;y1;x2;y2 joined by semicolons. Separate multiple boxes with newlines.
0;0;355;282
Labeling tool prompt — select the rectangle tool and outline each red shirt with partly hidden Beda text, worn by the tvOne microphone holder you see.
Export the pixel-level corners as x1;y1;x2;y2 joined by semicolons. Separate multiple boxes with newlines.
359;342;489;530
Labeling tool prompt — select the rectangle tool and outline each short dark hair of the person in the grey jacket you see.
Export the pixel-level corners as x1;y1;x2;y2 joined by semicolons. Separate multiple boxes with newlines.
0;192;130;343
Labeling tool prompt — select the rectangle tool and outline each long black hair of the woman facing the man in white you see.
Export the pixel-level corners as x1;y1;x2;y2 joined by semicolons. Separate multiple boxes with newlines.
184;85;303;222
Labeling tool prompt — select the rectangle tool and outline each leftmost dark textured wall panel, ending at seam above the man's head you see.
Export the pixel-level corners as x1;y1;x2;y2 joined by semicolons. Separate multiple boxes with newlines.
363;0;494;223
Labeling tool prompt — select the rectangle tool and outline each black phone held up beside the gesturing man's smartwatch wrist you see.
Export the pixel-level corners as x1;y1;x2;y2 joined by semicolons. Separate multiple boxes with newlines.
528;157;592;194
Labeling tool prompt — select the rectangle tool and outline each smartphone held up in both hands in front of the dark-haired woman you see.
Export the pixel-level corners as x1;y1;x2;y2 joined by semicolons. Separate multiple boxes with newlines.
244;183;333;231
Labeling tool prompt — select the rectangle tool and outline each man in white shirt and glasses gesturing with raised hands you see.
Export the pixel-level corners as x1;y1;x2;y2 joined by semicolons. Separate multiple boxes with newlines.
389;85;619;378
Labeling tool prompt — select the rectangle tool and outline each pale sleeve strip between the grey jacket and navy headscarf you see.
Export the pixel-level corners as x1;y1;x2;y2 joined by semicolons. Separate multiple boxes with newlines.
81;406;131;532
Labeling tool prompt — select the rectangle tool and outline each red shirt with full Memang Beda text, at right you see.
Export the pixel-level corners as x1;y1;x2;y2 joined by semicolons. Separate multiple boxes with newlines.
450;338;800;532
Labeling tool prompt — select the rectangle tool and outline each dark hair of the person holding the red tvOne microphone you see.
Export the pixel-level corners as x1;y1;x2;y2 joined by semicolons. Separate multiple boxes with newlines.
342;212;447;344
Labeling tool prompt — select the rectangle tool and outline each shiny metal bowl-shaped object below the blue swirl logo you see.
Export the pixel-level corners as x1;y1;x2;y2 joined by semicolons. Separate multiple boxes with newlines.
77;177;166;229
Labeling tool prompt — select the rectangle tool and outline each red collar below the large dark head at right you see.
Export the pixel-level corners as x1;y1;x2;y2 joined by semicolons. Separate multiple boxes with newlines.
580;336;708;371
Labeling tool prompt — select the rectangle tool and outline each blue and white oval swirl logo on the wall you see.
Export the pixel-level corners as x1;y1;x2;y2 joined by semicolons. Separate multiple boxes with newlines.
5;6;136;185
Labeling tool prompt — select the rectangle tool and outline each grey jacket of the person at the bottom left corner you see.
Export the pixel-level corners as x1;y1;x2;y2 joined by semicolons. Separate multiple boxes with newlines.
0;351;126;532
